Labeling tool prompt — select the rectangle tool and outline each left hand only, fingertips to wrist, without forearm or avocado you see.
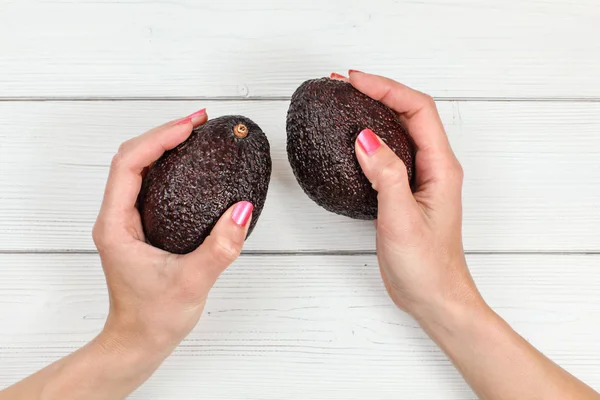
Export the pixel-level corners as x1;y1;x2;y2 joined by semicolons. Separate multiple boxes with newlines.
93;110;252;354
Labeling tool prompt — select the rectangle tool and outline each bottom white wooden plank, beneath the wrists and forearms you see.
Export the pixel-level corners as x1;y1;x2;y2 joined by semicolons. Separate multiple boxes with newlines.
0;254;600;400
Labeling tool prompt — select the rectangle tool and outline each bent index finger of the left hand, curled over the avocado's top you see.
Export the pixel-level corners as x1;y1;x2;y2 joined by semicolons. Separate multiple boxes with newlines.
102;110;208;219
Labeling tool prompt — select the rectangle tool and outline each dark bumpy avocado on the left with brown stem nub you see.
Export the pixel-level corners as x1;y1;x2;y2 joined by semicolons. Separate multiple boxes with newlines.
138;116;271;254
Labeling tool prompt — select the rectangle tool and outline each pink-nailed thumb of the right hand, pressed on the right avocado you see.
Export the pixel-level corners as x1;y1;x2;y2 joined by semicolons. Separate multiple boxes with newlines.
355;129;416;215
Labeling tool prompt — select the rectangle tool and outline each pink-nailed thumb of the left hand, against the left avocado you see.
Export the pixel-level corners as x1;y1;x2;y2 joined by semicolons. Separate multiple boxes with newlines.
182;201;254;287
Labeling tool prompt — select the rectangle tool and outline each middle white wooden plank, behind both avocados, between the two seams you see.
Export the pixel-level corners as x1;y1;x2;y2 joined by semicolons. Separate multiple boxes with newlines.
0;102;600;251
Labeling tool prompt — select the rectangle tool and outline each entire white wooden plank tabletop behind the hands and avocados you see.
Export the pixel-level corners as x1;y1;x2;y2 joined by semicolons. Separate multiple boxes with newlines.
0;0;600;400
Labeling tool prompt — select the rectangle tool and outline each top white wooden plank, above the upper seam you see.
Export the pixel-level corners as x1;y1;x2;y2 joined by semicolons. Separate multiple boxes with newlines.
0;0;600;98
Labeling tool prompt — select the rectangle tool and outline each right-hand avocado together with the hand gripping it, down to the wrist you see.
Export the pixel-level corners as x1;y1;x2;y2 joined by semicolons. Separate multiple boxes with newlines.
287;71;478;322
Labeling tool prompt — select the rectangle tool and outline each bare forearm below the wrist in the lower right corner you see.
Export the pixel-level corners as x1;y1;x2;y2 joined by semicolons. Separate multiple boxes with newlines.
418;300;600;400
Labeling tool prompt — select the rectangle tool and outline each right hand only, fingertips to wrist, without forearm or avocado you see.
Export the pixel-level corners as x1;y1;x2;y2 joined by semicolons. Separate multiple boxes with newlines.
350;71;480;319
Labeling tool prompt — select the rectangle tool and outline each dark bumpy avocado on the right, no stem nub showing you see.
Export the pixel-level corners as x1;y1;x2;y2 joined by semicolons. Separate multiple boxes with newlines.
287;78;415;220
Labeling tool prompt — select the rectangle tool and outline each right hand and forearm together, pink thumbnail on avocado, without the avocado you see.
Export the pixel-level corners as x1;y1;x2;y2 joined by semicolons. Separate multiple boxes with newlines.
346;71;600;400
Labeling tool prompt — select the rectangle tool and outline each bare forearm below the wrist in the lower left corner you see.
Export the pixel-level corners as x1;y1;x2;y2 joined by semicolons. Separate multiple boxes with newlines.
0;333;167;400
